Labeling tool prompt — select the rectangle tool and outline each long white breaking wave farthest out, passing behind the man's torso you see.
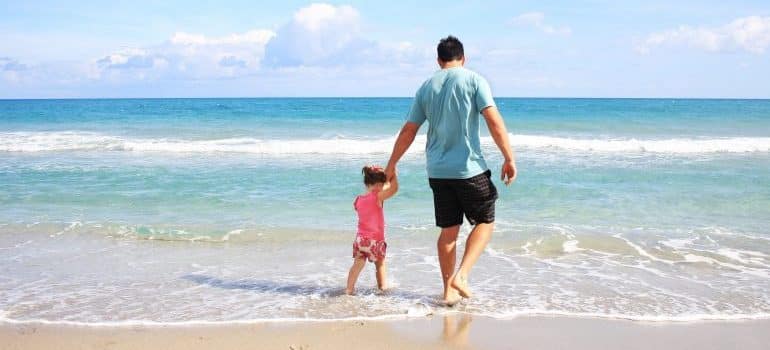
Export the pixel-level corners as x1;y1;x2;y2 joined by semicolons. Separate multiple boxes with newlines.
0;131;770;155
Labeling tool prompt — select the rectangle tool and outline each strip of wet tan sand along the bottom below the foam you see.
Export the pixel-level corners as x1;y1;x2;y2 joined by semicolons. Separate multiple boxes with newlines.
0;314;770;350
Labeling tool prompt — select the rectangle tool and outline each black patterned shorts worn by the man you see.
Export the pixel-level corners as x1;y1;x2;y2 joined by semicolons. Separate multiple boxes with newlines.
428;170;497;228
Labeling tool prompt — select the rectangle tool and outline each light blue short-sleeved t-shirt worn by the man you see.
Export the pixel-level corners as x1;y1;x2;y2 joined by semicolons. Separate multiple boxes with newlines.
407;67;495;179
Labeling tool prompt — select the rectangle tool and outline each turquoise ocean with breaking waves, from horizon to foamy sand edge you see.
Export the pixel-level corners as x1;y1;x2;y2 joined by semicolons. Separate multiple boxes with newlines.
0;98;770;324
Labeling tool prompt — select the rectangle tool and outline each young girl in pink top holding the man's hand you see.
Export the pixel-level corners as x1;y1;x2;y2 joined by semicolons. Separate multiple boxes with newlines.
345;165;398;295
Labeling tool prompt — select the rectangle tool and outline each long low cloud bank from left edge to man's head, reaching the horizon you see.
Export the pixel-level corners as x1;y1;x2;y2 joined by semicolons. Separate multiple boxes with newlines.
0;4;436;96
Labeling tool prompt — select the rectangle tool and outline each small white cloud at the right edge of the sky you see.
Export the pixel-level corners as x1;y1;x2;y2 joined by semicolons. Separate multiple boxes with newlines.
635;16;770;54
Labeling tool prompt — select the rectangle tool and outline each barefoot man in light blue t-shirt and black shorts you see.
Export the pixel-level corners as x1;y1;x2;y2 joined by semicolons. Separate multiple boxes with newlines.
385;36;516;305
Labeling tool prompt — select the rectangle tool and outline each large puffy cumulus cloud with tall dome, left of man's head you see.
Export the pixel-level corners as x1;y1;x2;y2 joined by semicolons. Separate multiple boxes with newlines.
88;3;428;81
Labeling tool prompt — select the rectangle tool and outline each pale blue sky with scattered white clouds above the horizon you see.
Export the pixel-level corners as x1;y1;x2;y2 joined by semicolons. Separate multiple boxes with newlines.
0;0;770;98
